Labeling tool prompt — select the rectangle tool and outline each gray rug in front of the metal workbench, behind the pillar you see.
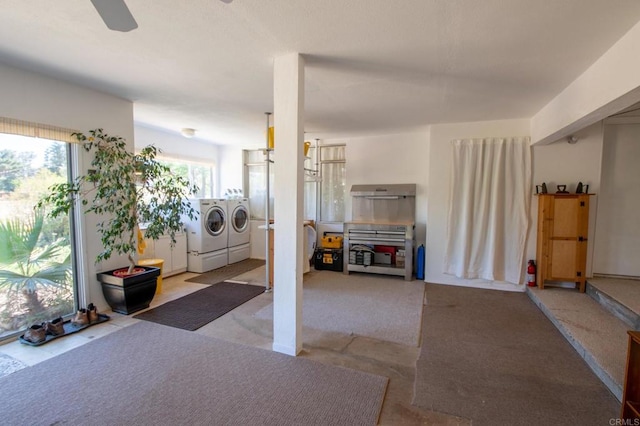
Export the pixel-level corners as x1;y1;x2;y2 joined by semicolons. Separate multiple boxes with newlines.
254;271;424;347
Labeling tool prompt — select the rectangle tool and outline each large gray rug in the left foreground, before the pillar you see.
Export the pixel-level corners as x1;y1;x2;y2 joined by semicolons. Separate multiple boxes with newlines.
0;322;388;426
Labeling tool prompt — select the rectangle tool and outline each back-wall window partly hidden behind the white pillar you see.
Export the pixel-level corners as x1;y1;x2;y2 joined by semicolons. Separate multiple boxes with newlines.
244;145;346;222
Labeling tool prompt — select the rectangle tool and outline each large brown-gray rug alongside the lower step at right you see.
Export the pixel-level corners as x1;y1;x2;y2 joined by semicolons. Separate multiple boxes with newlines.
414;284;620;425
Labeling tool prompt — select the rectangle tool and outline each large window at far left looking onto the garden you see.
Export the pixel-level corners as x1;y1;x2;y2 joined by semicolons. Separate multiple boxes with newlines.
0;133;76;339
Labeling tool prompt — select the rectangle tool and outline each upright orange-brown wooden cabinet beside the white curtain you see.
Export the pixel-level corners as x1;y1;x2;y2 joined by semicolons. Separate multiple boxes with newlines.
536;194;589;293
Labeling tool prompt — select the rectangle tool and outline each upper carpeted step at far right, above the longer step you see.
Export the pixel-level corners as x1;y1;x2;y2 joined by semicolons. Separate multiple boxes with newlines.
587;277;640;330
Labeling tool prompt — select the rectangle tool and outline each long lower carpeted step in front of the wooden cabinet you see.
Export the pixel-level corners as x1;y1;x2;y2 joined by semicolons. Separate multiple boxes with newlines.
527;287;629;400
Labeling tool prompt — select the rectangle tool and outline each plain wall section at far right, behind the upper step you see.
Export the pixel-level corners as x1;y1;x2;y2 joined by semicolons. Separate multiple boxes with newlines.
590;124;640;277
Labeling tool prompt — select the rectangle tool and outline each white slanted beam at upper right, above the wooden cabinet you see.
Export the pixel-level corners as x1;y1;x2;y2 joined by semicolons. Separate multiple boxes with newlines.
531;23;640;144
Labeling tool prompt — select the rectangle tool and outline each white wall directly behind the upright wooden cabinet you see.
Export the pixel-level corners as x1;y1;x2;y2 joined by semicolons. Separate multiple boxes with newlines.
526;122;603;277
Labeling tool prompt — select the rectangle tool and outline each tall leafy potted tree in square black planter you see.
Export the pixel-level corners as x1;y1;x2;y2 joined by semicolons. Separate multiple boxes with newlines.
36;129;197;314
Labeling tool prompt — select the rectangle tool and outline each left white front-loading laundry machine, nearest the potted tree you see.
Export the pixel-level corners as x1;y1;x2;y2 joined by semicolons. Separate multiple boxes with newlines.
184;198;229;273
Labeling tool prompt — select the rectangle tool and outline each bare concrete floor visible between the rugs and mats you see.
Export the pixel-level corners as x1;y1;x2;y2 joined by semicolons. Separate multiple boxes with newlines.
0;267;462;425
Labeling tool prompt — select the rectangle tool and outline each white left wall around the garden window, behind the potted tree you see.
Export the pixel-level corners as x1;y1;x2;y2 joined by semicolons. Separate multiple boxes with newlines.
0;65;133;309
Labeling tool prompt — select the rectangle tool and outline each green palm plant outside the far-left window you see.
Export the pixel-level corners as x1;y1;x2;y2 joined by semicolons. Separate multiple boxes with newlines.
0;210;72;315
